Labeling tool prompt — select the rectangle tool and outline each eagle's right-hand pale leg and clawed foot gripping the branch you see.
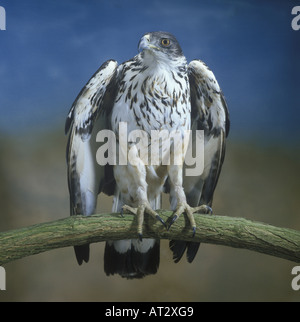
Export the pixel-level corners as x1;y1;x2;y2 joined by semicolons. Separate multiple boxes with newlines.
168;165;212;236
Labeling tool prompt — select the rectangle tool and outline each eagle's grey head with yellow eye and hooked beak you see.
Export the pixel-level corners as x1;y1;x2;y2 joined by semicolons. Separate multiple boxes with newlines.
138;31;184;63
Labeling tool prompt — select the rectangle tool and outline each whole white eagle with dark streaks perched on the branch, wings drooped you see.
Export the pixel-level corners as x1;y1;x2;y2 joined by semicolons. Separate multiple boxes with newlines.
65;31;229;278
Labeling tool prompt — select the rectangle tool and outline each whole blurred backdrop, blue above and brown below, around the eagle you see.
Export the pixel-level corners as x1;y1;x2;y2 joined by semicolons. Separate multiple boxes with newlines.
0;0;300;301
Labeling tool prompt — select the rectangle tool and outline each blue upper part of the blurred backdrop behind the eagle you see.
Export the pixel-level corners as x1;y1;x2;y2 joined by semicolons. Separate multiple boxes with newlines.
0;0;300;143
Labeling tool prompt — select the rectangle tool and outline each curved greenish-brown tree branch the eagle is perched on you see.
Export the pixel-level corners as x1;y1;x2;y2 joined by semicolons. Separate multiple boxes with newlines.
0;210;300;265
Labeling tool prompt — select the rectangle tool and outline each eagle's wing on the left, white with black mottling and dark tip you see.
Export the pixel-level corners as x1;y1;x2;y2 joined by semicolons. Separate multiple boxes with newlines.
65;60;118;264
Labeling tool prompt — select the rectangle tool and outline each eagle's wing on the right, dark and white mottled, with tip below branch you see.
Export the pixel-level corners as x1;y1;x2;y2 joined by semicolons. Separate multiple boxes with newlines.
170;60;230;262
